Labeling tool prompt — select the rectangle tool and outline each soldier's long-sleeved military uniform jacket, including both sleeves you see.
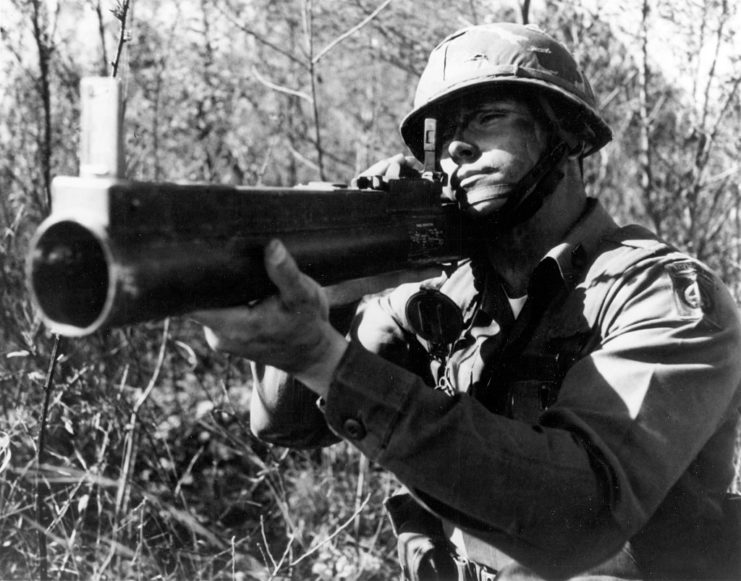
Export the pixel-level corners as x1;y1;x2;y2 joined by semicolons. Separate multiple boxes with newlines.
252;200;741;579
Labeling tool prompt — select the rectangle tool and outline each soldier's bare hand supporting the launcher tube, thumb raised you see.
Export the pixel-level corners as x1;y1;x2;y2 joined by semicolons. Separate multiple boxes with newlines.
192;240;347;395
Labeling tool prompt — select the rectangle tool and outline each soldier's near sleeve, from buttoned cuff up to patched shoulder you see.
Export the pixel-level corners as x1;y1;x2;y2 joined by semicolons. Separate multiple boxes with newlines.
325;264;741;576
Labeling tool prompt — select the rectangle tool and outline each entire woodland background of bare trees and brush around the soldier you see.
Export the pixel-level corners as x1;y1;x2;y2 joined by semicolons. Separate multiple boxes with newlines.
0;0;741;580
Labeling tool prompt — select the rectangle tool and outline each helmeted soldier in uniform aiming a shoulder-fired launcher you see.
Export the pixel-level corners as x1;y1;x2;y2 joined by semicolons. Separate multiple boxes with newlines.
196;24;741;579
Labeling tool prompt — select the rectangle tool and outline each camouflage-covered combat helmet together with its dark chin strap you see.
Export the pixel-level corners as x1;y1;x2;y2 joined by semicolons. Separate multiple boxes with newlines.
400;23;612;227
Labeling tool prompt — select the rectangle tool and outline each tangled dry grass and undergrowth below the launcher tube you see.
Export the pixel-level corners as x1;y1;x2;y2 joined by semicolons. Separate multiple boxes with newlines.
0;322;397;580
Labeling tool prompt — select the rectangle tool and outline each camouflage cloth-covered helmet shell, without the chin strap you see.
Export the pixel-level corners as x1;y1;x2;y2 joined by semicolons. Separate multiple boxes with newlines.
400;23;612;159
